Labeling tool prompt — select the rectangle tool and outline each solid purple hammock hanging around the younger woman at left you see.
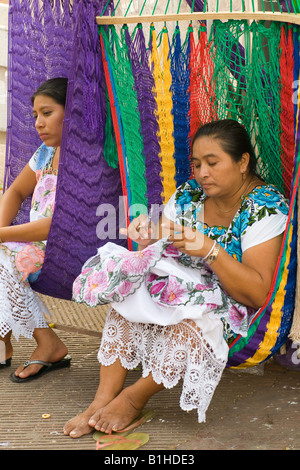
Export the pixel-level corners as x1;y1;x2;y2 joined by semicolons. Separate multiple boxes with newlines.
4;0;126;299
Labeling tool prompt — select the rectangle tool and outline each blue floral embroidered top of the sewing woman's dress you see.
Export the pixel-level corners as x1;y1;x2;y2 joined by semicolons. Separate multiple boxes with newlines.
173;180;288;261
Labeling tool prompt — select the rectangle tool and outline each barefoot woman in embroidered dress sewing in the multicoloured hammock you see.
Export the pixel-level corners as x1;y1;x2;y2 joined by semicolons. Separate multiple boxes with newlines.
64;120;288;437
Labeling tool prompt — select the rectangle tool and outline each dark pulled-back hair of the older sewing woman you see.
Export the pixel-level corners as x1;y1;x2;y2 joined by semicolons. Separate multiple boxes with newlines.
193;119;257;174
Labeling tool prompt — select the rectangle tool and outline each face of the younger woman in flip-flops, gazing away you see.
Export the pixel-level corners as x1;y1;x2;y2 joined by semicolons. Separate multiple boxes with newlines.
33;95;65;147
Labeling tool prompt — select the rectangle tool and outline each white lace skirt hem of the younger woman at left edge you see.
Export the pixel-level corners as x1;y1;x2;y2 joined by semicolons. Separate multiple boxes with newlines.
0;250;50;340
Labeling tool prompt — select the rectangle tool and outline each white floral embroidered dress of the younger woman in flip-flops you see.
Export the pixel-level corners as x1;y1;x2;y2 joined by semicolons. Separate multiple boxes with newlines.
0;144;57;339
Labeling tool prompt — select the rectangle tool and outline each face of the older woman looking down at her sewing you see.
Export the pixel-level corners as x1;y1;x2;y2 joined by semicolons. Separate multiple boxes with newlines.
192;137;249;197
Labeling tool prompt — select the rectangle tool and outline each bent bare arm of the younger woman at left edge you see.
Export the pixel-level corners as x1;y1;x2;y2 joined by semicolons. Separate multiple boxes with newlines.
0;164;52;242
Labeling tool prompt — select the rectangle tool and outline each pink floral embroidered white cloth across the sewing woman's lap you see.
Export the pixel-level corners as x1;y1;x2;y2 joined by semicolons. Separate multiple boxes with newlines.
73;239;249;335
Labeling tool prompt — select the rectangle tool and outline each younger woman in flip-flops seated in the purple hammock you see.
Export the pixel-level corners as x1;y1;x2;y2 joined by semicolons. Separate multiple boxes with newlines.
0;78;70;382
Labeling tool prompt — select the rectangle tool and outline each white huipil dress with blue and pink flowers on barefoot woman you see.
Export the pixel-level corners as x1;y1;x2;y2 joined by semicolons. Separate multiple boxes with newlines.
73;180;287;422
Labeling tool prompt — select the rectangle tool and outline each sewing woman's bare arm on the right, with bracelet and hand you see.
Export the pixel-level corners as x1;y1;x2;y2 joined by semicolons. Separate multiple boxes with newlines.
169;222;283;309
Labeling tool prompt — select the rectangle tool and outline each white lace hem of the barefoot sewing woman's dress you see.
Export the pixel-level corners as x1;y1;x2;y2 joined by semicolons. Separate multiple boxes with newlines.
98;309;227;423
